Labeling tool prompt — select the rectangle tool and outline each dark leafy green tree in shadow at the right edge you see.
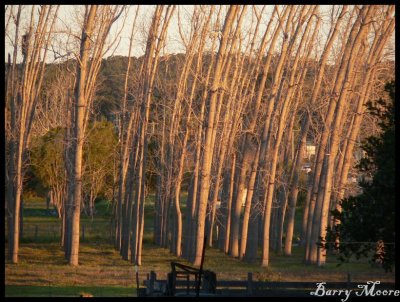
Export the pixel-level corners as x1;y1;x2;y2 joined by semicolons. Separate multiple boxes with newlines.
328;82;395;271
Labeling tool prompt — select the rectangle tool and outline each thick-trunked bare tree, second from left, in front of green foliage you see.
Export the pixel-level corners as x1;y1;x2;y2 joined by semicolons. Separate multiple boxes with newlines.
66;5;123;266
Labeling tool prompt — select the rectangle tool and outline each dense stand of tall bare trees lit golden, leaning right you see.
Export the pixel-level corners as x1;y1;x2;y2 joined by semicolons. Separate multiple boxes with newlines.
6;5;395;266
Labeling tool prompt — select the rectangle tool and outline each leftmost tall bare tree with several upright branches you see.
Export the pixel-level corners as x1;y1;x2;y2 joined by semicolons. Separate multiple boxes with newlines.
6;5;59;263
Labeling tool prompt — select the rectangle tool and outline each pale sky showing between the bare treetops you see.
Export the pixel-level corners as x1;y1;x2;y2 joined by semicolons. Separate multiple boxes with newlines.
5;5;394;62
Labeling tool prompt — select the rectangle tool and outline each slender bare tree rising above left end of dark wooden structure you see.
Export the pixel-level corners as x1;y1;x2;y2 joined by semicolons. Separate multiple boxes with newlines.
121;6;175;265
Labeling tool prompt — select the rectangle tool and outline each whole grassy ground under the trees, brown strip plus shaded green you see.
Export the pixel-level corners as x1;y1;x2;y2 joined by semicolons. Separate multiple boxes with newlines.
5;198;394;297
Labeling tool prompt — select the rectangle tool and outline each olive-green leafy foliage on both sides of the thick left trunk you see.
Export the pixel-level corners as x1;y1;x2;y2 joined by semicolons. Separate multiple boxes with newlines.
27;121;117;208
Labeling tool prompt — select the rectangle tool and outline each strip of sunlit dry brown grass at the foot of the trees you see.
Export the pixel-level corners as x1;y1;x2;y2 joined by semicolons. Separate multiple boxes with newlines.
5;243;394;287
